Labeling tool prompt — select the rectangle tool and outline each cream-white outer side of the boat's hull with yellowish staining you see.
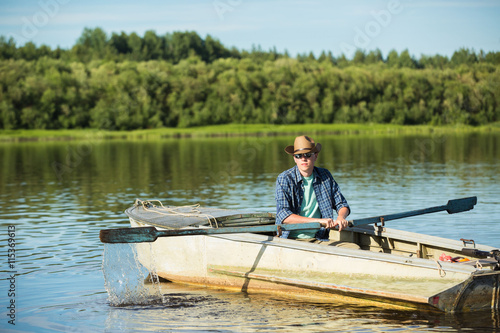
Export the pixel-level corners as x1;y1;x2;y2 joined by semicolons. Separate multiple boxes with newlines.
130;218;500;312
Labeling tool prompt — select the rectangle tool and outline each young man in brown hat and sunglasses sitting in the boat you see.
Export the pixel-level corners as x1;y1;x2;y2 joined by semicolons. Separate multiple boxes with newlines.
276;136;350;239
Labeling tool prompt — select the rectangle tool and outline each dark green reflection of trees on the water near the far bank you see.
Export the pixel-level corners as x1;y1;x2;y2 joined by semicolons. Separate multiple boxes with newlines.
0;133;500;207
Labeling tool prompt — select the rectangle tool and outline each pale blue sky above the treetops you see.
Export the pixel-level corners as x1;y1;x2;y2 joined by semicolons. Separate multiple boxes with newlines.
0;0;500;57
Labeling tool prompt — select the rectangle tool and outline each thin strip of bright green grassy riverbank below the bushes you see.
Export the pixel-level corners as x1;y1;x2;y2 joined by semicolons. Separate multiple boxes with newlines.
0;123;500;142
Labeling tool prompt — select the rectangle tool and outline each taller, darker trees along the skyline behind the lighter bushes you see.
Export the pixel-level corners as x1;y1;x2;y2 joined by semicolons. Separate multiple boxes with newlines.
0;28;500;69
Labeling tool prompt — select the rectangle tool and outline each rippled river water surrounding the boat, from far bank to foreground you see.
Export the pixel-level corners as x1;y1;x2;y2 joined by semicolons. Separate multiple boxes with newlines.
0;133;500;332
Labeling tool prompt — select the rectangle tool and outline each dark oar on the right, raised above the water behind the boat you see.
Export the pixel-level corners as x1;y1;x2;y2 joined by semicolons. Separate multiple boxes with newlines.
349;197;477;227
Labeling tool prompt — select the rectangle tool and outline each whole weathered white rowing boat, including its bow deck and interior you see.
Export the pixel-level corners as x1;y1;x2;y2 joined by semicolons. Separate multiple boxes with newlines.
122;202;500;312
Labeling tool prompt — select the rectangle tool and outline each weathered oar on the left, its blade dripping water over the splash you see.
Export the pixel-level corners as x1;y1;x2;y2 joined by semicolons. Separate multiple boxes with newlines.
99;222;321;243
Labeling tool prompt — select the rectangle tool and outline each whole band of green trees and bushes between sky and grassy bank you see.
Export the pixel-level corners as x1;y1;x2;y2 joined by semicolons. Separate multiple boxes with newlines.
0;28;500;130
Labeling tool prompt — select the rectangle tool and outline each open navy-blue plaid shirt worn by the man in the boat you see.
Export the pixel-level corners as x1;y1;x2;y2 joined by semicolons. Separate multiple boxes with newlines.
275;166;350;238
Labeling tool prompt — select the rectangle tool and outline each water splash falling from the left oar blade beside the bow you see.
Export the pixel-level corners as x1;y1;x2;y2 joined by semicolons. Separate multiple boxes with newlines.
102;244;165;306
